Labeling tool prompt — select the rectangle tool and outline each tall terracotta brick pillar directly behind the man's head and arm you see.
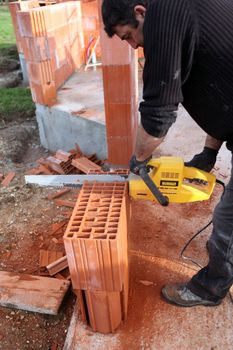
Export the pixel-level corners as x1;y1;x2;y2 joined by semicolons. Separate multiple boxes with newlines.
99;0;138;165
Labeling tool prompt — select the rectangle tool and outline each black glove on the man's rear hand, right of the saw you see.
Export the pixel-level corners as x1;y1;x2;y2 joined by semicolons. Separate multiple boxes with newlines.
184;147;218;171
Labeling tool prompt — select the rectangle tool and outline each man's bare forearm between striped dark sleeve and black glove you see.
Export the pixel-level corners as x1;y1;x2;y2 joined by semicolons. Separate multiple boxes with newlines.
135;124;164;161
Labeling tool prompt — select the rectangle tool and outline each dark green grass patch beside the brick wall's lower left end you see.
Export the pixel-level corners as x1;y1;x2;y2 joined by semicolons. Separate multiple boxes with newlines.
0;88;35;121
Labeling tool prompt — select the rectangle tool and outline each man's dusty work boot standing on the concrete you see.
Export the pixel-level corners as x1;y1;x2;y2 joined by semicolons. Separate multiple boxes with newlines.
162;283;222;307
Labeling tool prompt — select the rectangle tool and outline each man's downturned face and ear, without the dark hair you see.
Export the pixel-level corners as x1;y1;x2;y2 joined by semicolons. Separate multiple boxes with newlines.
114;5;146;49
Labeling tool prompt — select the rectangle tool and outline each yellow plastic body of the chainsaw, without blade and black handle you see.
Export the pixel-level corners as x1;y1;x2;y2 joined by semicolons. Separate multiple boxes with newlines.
129;157;216;203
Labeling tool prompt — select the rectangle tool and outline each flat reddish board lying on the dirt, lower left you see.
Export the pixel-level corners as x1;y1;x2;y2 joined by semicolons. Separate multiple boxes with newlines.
0;271;70;315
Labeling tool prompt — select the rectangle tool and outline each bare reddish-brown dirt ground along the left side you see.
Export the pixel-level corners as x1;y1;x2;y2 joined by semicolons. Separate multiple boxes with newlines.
0;119;77;350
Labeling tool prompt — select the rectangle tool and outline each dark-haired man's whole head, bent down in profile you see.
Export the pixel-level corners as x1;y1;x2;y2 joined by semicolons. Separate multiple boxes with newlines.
102;0;148;49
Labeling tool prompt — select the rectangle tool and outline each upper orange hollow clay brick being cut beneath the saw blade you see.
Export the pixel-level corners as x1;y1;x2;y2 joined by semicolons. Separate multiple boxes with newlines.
64;183;128;291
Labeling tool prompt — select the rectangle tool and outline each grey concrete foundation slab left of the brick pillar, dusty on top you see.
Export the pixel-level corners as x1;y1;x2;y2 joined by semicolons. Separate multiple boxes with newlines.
36;70;107;159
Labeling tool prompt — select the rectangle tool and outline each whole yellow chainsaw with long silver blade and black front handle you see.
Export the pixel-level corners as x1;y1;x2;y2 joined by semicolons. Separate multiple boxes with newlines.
25;157;216;206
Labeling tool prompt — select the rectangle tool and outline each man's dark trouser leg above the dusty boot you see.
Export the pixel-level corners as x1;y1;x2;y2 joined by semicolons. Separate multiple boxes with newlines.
188;157;233;301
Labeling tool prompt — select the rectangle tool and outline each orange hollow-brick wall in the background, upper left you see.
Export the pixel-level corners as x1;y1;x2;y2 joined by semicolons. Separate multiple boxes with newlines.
11;1;84;106
